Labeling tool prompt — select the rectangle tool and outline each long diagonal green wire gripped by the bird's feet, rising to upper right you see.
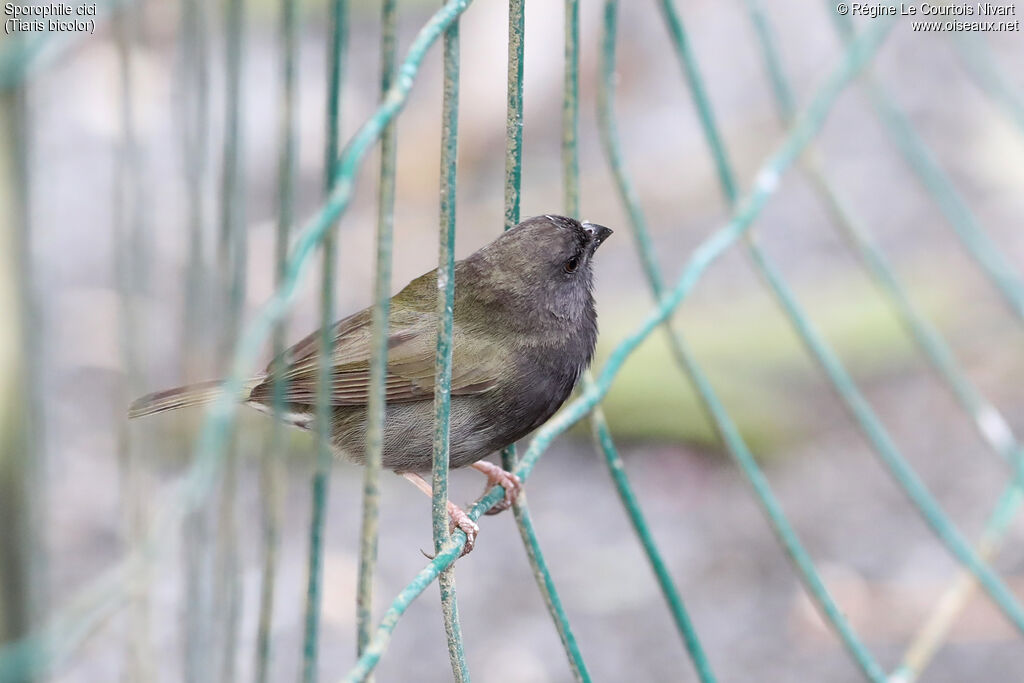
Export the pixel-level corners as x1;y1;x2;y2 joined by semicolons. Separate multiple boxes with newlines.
339;20;892;682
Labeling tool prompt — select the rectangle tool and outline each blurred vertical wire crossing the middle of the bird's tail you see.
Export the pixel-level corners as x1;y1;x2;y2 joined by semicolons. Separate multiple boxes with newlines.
181;0;212;683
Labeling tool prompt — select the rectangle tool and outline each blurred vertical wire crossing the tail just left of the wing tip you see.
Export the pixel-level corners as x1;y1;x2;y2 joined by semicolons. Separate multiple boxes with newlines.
214;0;247;683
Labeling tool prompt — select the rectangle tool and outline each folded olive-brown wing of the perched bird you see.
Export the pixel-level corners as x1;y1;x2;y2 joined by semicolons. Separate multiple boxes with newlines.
251;309;501;405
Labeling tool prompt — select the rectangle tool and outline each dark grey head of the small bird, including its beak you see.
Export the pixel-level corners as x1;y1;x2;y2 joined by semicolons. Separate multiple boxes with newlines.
467;215;611;331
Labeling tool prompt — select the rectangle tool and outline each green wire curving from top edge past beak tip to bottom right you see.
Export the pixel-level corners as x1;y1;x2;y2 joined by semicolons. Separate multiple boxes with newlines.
598;0;885;681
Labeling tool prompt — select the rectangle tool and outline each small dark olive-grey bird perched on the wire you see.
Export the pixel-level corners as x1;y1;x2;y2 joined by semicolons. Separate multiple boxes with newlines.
129;215;611;554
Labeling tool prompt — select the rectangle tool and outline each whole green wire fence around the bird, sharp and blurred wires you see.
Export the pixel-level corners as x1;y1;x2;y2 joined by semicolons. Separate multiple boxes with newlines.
0;0;1024;682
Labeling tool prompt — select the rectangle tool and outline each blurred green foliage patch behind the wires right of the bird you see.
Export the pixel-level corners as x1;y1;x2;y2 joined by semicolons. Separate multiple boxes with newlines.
595;266;963;455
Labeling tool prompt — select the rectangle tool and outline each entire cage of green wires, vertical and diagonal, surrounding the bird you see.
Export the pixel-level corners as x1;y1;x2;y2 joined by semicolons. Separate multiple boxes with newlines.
0;0;1024;682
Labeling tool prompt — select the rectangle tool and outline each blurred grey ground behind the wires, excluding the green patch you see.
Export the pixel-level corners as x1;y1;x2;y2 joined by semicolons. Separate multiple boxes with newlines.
14;1;1024;682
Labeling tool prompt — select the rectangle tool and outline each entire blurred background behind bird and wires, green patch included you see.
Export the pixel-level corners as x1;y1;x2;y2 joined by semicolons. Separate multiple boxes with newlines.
0;0;1024;682
